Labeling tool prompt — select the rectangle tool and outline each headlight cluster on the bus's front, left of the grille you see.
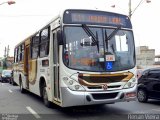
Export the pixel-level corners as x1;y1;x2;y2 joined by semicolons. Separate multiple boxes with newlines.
63;77;85;91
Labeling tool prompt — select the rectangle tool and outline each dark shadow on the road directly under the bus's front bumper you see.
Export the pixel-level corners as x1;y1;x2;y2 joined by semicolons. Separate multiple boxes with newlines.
47;104;128;120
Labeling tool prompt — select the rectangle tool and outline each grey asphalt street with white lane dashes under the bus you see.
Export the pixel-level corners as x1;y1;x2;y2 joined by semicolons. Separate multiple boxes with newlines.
0;83;160;120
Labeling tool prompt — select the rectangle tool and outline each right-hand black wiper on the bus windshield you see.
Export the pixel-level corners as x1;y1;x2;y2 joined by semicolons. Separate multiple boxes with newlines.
105;26;121;52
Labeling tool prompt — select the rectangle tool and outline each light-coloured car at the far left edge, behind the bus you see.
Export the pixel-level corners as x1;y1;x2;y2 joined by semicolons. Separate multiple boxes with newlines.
1;70;12;82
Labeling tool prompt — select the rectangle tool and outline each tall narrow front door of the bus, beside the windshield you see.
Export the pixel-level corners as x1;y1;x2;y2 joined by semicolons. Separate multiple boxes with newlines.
53;30;60;101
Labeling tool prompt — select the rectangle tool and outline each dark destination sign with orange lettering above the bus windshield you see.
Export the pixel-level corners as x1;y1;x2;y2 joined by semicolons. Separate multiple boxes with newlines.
63;10;132;28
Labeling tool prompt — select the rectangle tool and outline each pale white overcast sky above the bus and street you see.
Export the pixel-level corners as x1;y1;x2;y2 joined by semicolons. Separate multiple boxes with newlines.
0;0;160;57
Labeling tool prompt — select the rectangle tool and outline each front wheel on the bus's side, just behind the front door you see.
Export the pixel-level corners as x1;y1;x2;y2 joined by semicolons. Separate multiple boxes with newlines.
42;85;51;108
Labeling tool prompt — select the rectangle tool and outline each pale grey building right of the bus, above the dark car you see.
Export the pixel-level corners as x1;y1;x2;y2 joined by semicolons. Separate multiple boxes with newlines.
136;46;155;68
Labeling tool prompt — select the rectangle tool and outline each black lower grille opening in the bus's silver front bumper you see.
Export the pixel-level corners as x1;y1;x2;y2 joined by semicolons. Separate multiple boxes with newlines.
92;92;118;100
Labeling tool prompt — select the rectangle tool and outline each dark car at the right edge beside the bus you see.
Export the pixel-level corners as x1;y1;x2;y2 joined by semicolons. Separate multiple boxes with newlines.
137;68;160;102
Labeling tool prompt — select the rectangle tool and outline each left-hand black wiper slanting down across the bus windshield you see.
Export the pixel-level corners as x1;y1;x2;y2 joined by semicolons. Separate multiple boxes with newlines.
82;24;99;52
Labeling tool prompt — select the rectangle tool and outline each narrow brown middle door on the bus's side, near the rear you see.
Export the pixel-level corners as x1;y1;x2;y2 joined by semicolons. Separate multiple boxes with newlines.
24;45;29;89
